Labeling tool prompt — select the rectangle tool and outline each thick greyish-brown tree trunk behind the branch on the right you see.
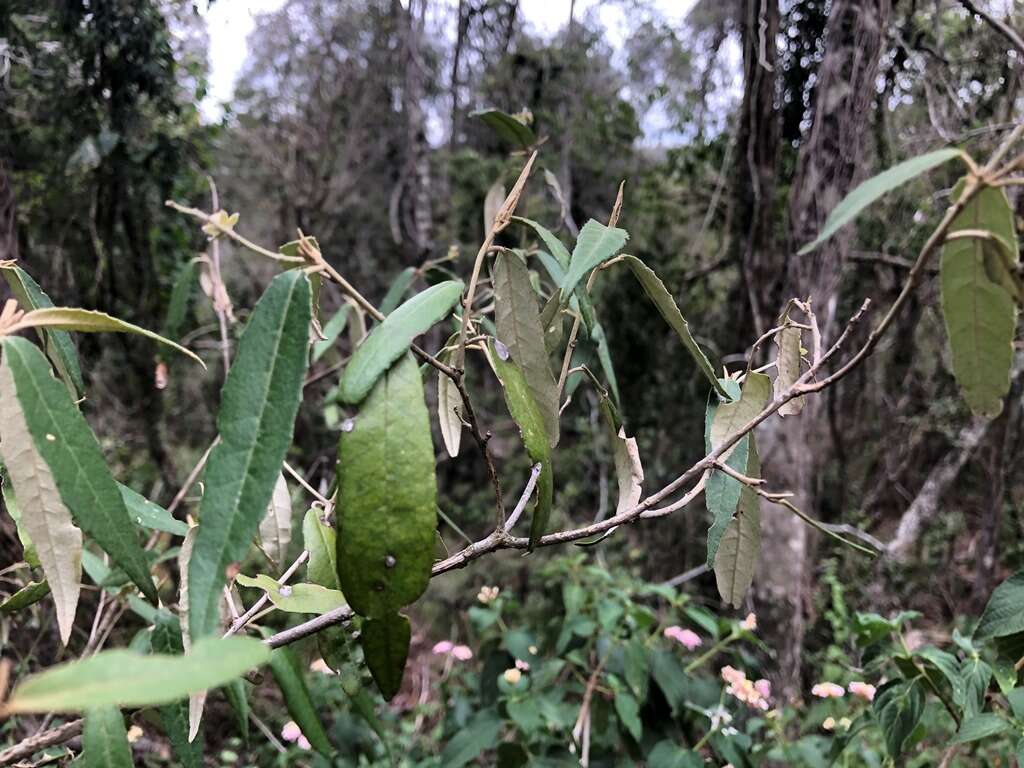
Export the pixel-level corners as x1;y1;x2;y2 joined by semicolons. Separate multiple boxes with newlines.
758;0;892;698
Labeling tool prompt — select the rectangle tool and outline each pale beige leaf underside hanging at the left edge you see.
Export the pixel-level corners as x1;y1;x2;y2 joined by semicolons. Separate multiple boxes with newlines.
0;357;82;645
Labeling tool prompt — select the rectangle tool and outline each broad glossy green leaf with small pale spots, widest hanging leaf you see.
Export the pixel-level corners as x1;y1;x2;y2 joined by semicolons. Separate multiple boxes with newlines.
337;354;437;617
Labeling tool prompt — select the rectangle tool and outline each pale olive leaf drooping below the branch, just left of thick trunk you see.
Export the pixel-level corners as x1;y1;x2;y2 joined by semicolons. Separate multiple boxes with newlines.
715;436;761;608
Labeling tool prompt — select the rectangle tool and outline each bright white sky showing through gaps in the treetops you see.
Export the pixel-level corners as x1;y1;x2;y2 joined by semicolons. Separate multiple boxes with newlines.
201;0;693;120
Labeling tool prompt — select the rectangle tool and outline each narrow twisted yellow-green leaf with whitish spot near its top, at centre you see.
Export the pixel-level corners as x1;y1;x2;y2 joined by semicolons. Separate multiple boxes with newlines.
486;340;554;550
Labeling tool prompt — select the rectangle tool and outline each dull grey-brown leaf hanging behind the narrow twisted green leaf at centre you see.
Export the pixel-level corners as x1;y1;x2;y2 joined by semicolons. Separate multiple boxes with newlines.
494;253;561;447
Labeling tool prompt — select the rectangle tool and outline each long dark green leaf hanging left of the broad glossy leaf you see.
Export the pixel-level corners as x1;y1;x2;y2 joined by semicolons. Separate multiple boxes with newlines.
188;269;310;639
